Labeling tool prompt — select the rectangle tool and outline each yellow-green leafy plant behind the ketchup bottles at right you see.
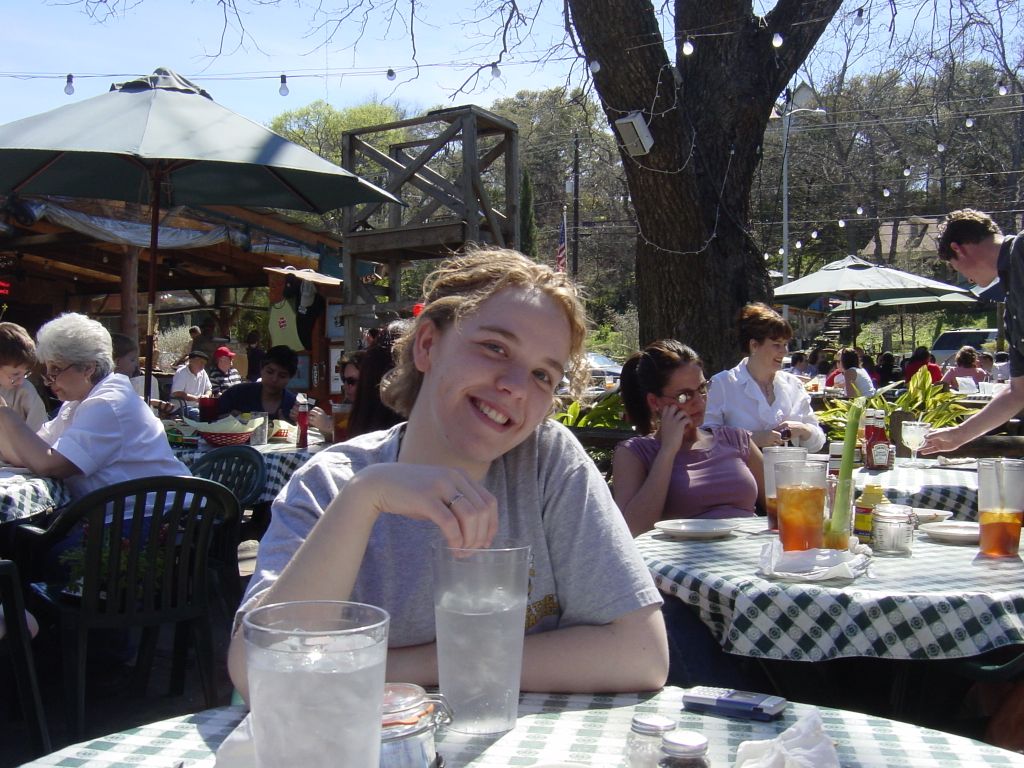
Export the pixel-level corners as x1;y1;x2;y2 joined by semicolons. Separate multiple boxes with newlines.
818;367;971;440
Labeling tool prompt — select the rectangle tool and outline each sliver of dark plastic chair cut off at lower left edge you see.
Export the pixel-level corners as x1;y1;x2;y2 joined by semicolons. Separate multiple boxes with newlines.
0;560;53;755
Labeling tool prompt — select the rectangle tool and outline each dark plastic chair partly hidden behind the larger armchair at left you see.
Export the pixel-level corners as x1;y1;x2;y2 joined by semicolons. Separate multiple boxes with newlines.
191;445;266;616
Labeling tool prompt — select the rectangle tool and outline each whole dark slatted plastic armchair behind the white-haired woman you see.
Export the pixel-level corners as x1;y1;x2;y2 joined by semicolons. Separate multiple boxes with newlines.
19;477;239;737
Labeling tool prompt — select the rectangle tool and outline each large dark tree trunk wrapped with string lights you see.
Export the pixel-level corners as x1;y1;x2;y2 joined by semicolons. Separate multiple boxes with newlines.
569;0;842;375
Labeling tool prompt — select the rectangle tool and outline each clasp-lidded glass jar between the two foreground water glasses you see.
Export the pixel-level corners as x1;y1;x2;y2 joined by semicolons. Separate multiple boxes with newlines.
380;683;452;768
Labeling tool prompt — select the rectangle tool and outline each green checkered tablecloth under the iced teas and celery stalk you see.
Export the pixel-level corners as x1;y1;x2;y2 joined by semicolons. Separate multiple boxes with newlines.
636;518;1024;662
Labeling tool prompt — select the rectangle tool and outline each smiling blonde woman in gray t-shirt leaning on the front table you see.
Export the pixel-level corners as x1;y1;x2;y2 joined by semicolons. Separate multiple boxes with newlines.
228;250;668;693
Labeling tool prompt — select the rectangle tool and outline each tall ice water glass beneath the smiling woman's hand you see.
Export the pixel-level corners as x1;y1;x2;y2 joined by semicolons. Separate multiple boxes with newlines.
434;546;529;734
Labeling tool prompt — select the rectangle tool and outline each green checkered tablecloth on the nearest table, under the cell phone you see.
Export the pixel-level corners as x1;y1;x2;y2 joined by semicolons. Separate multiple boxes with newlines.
19;688;1024;768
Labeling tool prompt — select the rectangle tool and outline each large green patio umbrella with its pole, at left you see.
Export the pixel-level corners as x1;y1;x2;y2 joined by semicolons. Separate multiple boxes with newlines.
0;69;400;398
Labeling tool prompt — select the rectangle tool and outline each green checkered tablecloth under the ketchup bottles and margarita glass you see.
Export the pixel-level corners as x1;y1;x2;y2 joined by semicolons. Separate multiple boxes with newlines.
854;459;978;520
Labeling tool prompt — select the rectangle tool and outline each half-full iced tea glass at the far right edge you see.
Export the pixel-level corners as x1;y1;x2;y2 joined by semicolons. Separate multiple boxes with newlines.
978;459;1024;557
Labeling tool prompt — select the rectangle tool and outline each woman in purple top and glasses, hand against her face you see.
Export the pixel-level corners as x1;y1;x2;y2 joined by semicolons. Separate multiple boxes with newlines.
612;339;764;536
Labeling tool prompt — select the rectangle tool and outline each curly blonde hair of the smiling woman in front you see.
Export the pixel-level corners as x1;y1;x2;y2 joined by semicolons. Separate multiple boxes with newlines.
381;248;590;417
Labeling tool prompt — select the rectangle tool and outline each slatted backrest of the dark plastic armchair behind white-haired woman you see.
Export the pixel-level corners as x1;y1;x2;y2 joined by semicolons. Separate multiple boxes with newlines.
29;476;240;626
